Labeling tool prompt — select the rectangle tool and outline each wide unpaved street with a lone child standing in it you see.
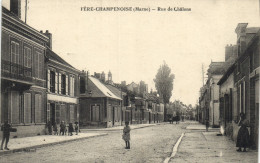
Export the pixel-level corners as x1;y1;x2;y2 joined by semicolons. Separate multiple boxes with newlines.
0;123;188;163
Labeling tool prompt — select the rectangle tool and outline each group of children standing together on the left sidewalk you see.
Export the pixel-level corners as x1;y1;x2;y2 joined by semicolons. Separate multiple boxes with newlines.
47;121;79;136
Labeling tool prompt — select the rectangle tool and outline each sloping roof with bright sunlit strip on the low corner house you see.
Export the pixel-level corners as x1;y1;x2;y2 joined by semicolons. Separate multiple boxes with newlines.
89;76;122;100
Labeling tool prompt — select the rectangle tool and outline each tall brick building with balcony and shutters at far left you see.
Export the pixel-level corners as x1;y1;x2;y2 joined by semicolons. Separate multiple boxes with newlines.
0;0;49;137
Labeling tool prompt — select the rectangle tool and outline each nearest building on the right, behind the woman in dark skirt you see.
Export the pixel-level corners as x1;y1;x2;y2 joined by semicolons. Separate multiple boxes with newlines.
218;23;260;148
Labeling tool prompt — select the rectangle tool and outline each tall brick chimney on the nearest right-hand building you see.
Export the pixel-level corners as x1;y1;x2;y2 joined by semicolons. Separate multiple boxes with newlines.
235;23;248;56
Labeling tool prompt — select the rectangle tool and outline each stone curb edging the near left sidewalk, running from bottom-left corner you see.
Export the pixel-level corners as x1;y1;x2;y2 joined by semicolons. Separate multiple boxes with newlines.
0;133;108;156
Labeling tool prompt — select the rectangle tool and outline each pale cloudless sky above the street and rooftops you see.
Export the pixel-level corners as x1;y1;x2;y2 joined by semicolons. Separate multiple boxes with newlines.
2;0;260;105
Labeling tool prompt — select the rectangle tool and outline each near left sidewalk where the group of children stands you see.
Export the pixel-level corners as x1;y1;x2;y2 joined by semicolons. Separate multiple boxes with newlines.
0;133;107;155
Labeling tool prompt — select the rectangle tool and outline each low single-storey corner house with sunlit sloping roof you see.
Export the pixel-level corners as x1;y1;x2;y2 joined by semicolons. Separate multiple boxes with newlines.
79;73;122;127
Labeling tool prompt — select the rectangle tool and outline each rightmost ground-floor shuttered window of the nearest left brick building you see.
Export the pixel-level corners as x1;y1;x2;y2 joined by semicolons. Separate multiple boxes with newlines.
34;94;43;123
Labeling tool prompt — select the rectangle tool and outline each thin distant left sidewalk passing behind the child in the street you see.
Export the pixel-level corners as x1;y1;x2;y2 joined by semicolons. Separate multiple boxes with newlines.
80;123;159;132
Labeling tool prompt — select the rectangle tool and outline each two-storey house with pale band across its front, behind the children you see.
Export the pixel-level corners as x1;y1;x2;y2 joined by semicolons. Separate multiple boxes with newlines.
46;48;80;126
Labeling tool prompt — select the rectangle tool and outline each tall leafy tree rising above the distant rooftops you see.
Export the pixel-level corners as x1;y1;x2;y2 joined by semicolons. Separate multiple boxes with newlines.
154;61;174;104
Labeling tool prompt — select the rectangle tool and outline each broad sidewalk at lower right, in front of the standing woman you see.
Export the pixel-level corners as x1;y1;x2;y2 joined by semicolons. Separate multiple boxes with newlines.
170;132;258;163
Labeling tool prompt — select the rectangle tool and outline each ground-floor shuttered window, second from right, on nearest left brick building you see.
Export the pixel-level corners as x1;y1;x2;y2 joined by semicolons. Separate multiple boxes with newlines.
24;93;32;123
